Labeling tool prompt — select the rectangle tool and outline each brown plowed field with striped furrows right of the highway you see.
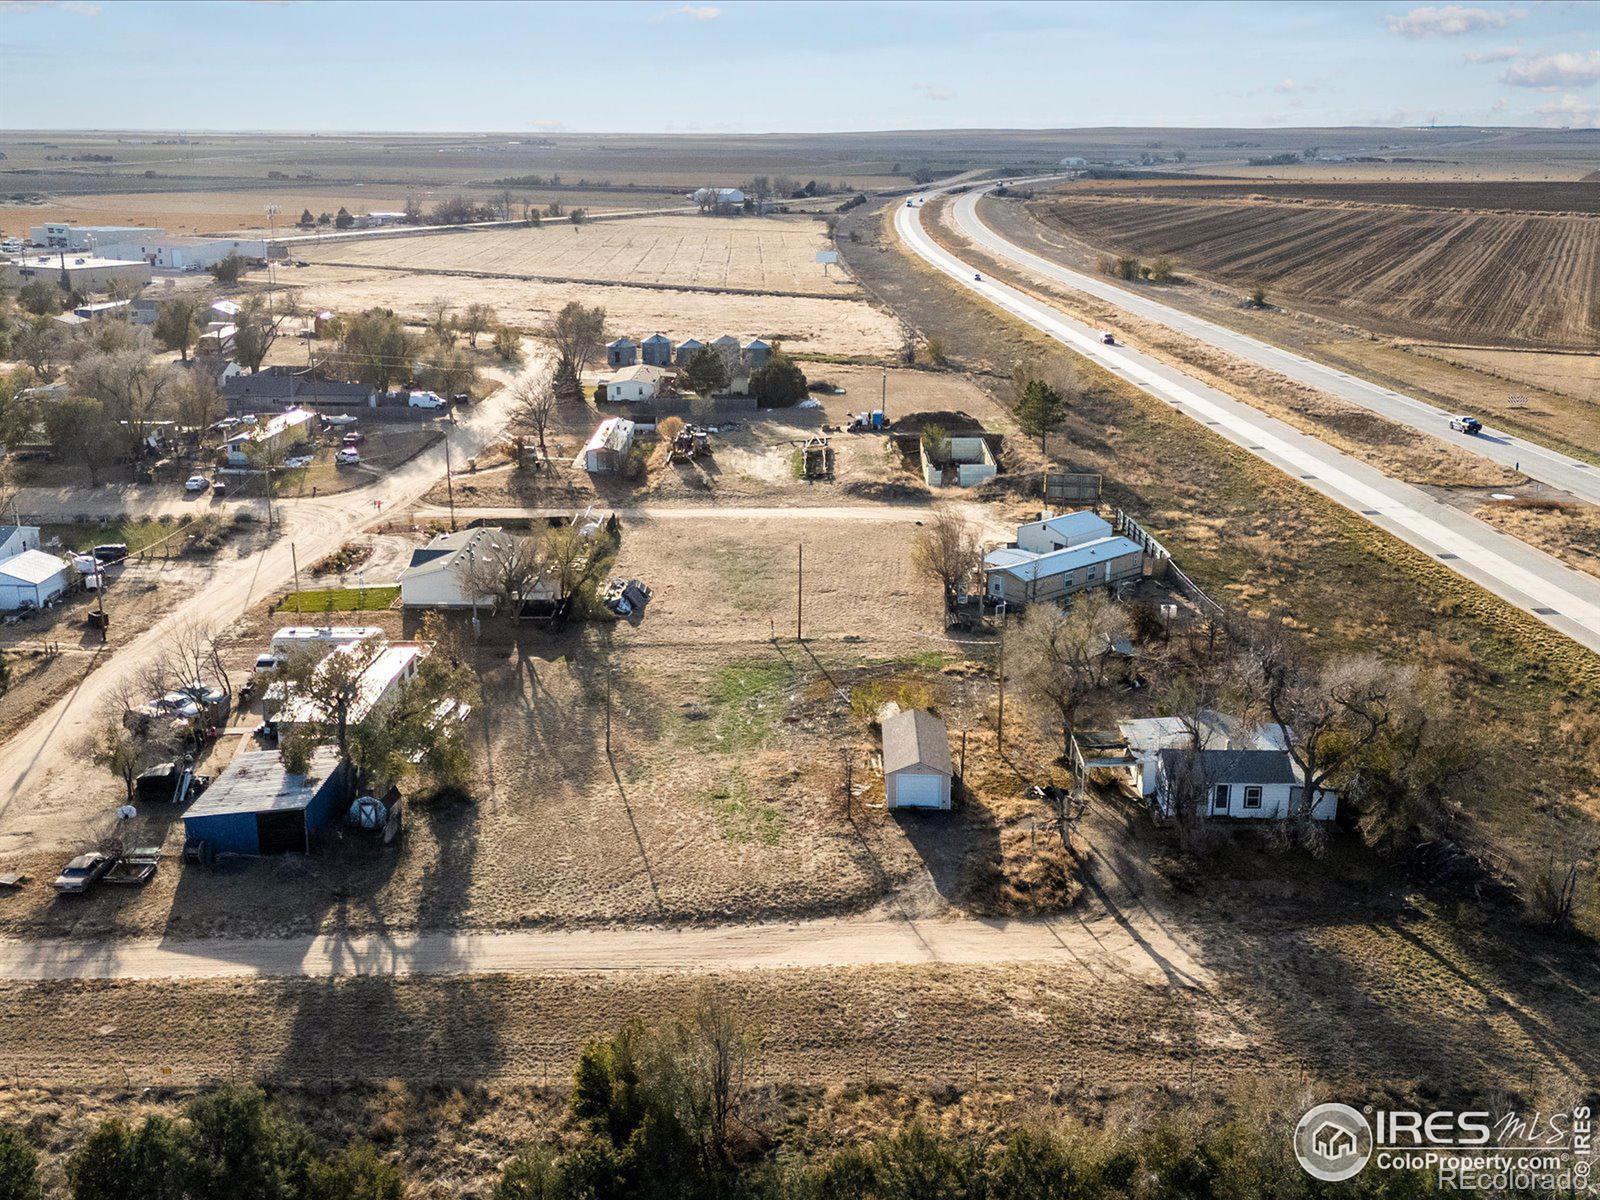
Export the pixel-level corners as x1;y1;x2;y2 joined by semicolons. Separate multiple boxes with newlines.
1037;192;1600;349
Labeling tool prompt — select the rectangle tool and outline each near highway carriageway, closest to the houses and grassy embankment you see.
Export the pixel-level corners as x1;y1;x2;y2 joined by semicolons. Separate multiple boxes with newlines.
894;192;1600;653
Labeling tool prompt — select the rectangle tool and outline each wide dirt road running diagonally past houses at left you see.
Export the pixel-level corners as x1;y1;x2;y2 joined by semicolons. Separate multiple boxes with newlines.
0;380;524;851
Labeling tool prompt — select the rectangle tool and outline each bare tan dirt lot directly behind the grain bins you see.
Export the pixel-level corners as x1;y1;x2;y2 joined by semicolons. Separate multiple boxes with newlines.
280;270;904;358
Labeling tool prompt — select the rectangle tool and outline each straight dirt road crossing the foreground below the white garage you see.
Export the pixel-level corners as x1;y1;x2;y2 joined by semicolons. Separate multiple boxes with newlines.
0;910;1211;989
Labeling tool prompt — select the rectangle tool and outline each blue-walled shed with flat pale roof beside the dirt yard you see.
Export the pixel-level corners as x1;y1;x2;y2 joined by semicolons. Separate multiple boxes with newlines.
184;746;350;854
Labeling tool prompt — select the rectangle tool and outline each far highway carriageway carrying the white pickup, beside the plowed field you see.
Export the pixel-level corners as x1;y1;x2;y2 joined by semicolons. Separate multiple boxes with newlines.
952;187;1600;504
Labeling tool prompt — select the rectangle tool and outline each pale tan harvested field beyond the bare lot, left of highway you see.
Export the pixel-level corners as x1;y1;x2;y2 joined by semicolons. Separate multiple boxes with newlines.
296;214;856;296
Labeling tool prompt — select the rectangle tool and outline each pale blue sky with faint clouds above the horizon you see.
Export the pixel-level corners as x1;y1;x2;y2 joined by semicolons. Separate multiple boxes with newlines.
0;0;1600;133
